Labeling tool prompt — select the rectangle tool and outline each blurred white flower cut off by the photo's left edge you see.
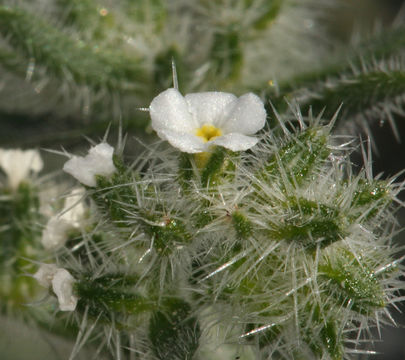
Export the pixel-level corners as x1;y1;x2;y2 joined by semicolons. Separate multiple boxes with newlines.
0;149;44;189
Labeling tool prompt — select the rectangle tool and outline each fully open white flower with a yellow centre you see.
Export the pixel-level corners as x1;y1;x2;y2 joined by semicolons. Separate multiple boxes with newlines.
149;89;266;153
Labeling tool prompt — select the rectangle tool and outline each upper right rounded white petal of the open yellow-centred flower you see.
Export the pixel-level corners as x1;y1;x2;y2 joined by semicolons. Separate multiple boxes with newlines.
221;93;266;135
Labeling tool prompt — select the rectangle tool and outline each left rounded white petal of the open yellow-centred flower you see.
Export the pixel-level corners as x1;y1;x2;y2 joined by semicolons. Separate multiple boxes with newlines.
149;89;198;133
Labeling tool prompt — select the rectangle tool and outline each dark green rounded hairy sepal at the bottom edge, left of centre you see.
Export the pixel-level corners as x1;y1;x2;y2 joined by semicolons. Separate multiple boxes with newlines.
149;298;201;360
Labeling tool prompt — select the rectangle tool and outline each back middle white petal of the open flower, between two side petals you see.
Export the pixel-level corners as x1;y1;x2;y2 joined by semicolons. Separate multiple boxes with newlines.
185;91;237;127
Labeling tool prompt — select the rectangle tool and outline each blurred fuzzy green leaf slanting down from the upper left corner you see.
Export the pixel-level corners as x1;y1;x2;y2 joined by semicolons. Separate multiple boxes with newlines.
0;6;145;91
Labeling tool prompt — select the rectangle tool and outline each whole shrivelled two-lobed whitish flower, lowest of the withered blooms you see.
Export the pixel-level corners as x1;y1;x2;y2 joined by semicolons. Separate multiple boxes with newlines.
34;264;78;311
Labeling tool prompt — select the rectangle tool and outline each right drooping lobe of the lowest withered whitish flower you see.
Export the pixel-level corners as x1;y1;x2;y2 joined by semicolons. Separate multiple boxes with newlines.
52;269;78;311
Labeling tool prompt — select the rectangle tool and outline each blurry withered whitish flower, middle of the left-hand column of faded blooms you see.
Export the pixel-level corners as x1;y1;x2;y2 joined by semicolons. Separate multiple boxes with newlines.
41;189;86;250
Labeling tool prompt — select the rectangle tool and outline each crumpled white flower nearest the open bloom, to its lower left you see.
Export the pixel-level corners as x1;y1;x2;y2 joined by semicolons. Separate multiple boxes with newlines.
63;143;116;186
